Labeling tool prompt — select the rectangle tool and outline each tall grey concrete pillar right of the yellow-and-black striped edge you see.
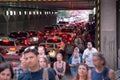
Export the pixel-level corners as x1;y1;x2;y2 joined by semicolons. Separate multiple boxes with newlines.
101;0;117;69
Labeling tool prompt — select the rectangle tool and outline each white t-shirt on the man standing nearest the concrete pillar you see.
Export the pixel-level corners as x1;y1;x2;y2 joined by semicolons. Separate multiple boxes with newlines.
83;48;98;67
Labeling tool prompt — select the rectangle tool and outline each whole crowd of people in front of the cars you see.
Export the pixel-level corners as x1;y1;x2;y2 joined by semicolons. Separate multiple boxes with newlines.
0;42;115;80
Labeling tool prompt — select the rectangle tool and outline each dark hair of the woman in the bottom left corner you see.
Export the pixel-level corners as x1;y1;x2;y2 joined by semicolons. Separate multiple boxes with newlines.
0;62;14;79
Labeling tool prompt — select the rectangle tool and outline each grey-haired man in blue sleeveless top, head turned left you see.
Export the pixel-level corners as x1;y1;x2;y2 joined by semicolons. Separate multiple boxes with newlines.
89;53;115;80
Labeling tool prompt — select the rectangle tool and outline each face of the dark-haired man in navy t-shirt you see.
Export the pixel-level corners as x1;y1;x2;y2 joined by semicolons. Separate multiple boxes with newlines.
24;52;39;68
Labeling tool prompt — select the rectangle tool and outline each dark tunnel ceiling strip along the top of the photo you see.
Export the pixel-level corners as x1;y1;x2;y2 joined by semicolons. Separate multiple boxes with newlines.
0;0;95;10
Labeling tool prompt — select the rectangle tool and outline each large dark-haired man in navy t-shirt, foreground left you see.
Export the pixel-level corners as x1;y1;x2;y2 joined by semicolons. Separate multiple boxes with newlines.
18;47;55;80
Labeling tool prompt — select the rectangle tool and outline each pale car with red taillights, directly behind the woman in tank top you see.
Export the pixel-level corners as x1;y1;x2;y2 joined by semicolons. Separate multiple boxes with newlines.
40;37;65;58
